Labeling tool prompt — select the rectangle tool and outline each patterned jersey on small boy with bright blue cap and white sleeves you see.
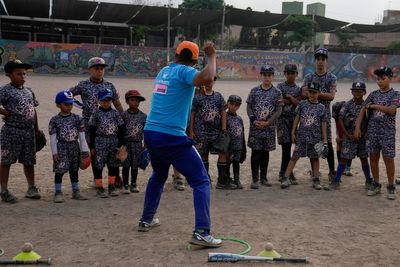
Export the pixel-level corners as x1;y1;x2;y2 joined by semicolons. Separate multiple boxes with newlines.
49;113;85;142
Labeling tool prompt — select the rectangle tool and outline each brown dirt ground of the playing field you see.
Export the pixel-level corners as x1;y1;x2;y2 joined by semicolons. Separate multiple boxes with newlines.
0;76;400;266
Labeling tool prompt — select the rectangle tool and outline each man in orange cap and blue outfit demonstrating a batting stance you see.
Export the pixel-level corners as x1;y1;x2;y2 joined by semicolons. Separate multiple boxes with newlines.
138;41;222;247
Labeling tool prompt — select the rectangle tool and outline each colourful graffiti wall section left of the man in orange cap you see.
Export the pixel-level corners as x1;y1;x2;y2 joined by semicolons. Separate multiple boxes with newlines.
0;39;167;77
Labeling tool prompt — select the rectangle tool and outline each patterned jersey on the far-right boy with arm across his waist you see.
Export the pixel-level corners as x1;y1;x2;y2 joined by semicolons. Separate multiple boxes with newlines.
364;89;400;135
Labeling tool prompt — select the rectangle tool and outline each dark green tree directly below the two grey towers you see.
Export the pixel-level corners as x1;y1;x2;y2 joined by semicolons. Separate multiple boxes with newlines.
279;15;316;46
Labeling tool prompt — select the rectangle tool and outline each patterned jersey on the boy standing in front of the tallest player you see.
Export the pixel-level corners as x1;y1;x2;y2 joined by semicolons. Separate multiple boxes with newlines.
296;100;326;144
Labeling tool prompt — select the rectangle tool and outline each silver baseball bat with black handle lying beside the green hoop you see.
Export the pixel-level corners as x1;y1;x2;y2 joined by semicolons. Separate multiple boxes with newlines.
208;253;308;263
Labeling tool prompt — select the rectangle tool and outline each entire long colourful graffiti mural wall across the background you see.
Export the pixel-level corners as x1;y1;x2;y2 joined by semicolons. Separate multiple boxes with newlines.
0;39;400;82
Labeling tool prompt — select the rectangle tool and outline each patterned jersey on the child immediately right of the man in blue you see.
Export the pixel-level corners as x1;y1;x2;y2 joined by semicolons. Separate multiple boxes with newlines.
192;91;225;139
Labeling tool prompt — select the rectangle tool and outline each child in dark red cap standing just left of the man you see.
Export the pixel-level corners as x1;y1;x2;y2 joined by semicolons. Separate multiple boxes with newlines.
121;90;147;194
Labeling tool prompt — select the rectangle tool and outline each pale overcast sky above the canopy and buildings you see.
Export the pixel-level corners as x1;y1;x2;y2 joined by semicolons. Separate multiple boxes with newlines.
93;0;400;24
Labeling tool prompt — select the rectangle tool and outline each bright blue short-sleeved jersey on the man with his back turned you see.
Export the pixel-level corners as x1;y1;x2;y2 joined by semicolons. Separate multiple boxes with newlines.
144;63;197;136
